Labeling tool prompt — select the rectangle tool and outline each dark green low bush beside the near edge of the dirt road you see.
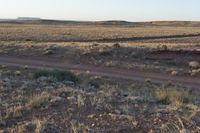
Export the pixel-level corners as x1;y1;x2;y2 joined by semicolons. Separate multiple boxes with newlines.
33;70;80;83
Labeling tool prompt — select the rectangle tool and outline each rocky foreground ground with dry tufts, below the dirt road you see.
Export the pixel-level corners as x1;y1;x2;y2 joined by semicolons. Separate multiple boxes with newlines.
0;66;200;133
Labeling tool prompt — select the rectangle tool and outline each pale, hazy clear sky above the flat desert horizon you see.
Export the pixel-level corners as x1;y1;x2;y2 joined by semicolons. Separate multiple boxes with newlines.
0;0;200;21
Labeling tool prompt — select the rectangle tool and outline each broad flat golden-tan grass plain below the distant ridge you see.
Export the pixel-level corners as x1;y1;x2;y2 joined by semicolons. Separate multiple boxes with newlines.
0;24;200;42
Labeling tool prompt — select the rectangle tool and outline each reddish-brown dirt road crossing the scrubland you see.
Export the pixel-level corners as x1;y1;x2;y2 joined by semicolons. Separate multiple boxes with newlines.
0;56;200;88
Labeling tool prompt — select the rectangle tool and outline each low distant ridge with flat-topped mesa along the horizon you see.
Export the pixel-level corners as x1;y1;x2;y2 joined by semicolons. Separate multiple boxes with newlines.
0;17;200;27
